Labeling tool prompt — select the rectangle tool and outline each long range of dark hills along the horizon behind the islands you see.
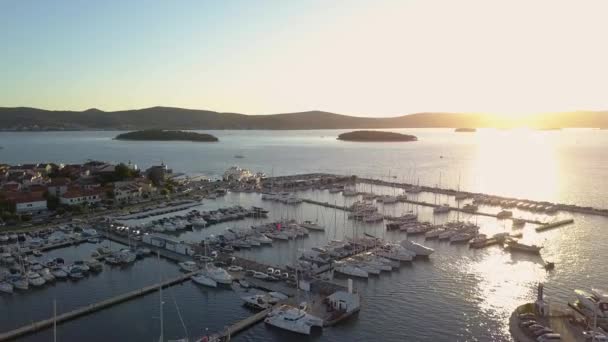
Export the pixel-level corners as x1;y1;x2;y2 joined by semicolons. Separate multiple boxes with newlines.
0;107;608;130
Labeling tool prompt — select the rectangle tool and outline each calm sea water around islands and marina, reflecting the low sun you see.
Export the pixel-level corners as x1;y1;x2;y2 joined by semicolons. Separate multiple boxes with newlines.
0;129;608;341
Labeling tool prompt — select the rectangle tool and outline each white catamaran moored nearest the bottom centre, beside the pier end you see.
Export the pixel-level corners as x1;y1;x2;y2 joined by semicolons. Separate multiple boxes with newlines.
264;305;323;335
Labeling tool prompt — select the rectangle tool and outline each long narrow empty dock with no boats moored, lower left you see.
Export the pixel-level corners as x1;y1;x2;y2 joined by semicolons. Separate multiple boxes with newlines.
0;273;194;341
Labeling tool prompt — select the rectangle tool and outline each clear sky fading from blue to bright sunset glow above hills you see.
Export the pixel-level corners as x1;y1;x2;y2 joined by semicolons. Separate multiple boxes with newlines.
0;0;608;116
